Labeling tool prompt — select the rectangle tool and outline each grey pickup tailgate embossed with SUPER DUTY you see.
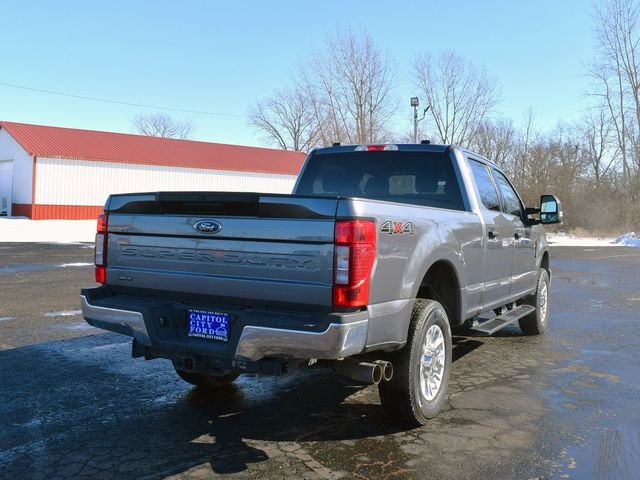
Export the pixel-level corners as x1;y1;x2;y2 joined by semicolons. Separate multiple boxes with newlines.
105;192;338;308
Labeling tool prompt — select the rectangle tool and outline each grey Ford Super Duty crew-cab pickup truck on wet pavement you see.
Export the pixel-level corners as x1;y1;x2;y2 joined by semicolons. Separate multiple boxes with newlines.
81;142;562;425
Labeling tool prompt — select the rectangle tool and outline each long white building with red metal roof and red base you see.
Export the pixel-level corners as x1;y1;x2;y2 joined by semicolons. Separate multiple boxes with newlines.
0;122;305;220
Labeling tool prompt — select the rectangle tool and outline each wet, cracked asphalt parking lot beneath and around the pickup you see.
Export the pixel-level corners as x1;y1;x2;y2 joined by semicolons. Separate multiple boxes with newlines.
0;243;640;479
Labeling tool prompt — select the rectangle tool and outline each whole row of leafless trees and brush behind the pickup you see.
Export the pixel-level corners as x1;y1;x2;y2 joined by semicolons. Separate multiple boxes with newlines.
249;0;640;233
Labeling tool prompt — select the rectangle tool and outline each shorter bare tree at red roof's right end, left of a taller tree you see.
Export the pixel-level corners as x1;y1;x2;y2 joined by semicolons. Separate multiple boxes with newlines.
249;85;318;152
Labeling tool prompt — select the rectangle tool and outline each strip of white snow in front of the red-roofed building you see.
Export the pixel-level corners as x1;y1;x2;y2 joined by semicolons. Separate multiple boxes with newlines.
0;217;96;244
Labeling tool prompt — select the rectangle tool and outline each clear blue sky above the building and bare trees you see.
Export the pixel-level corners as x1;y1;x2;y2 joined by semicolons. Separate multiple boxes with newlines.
0;0;594;146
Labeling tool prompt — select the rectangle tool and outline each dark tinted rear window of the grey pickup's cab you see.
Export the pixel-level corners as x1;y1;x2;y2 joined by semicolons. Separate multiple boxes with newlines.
296;151;464;210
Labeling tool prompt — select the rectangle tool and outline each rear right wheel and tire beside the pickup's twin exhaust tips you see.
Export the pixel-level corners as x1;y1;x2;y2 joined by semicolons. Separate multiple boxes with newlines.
378;299;452;427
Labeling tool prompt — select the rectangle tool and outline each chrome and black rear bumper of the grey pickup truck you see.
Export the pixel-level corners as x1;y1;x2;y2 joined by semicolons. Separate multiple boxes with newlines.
81;289;369;361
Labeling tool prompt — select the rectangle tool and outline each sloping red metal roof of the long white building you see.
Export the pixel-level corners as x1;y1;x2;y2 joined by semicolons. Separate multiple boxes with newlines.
0;122;305;175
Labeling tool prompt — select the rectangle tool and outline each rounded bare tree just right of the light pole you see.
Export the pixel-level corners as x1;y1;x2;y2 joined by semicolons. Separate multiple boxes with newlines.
414;52;500;145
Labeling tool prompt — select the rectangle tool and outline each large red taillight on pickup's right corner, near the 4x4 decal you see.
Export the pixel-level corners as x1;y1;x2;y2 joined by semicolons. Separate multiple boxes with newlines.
333;220;376;307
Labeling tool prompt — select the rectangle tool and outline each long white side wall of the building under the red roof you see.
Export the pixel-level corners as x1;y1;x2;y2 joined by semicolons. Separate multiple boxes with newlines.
35;158;297;205
